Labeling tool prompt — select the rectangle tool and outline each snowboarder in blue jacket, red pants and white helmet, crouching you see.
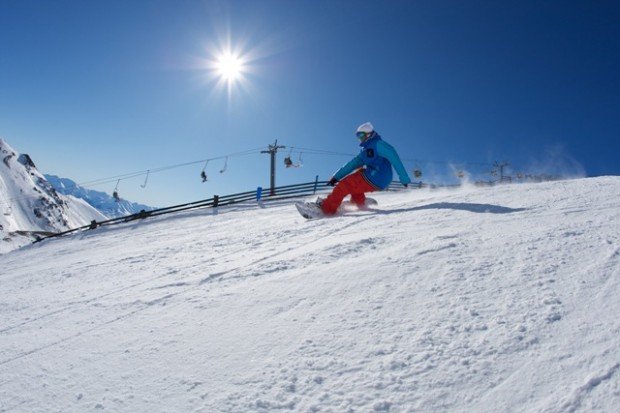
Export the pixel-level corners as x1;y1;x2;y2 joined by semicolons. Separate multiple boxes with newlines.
317;122;411;215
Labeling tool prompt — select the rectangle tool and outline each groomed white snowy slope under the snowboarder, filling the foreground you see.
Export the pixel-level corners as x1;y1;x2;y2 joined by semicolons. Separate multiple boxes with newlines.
0;177;620;412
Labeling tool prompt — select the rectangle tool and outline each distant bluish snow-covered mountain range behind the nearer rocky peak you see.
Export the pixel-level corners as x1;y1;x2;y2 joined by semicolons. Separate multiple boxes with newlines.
45;175;154;218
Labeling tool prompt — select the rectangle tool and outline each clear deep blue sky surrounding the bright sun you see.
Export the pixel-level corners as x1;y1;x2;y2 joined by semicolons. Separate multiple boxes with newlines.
0;0;620;206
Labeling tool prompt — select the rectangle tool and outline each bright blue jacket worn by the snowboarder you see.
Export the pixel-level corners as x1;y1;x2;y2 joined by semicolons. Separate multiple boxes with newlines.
334;132;411;189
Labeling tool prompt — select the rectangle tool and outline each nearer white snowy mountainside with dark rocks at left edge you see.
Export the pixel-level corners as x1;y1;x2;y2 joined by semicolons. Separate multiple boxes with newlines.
0;138;105;253
